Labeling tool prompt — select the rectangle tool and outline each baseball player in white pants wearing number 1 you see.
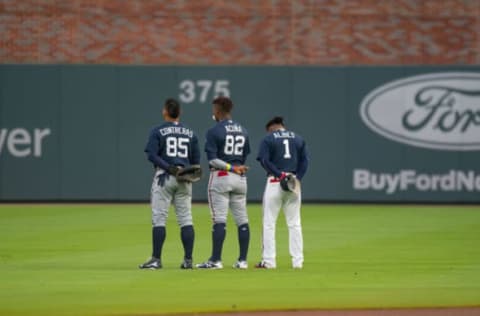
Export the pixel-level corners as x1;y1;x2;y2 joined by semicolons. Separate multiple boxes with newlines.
256;117;308;269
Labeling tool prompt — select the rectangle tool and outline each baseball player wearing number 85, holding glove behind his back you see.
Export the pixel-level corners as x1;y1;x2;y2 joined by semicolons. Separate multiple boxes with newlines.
139;99;200;269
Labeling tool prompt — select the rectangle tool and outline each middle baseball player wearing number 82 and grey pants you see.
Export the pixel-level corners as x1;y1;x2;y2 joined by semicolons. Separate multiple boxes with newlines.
197;97;250;269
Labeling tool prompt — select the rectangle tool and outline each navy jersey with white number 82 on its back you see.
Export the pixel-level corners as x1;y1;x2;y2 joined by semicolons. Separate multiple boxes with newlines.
205;120;250;165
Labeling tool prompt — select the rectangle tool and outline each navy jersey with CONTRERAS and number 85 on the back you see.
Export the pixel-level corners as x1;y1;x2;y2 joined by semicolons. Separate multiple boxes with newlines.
145;122;200;170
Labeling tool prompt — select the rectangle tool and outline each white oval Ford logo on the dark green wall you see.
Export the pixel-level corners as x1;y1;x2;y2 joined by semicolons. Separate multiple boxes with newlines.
360;72;480;151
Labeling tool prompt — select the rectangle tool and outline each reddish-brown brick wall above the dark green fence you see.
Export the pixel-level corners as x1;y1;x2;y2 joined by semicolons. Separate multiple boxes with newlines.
0;0;480;65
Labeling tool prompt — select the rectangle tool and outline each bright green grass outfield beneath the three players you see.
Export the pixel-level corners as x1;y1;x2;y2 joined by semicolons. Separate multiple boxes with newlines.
0;204;480;316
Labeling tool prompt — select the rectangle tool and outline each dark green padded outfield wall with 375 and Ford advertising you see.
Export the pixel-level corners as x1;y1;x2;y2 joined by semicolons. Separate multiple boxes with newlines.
0;65;480;202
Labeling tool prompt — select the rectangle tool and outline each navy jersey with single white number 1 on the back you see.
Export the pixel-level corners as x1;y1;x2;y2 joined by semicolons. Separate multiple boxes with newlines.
257;130;308;179
